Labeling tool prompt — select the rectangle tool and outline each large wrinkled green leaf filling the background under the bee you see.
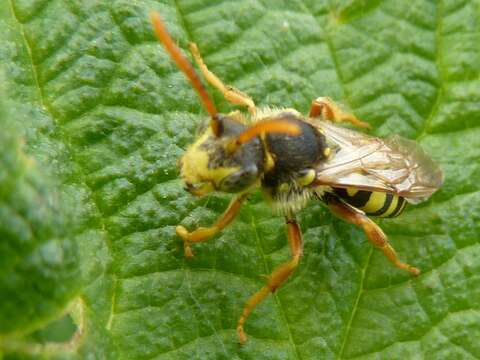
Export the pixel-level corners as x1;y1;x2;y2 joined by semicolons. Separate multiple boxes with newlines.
0;0;480;359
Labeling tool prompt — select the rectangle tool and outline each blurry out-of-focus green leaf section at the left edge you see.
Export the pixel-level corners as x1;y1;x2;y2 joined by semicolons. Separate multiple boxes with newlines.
0;93;78;334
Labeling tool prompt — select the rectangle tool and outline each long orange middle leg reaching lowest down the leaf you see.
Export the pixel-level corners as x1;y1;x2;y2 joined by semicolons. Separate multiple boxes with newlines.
237;216;303;344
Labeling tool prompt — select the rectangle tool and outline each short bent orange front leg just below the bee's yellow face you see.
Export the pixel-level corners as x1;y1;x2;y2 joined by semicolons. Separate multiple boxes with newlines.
175;194;248;257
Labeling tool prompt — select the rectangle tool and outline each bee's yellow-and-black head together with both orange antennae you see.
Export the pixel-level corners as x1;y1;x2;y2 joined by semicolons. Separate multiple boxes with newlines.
151;13;300;196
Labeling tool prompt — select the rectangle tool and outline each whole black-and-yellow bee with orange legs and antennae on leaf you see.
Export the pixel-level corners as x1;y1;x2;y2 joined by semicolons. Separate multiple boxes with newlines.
151;13;443;344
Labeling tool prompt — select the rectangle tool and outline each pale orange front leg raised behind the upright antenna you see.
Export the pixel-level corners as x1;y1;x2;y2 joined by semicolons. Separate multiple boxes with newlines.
189;43;256;115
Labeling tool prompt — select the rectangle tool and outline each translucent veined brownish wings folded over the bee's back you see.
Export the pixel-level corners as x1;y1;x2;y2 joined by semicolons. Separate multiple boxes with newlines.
314;121;443;203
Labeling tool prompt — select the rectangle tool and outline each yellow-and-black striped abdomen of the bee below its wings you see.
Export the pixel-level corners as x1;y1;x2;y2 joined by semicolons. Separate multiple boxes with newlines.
333;188;407;217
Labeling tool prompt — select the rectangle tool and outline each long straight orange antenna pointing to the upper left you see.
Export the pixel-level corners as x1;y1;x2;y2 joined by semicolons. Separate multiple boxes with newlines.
150;12;220;136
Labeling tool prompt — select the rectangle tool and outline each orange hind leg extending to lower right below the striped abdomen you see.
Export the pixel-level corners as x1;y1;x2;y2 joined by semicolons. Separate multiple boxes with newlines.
327;196;420;276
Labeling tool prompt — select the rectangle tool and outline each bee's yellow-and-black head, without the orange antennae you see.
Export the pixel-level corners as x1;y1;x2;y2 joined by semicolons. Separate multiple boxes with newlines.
180;114;265;196
